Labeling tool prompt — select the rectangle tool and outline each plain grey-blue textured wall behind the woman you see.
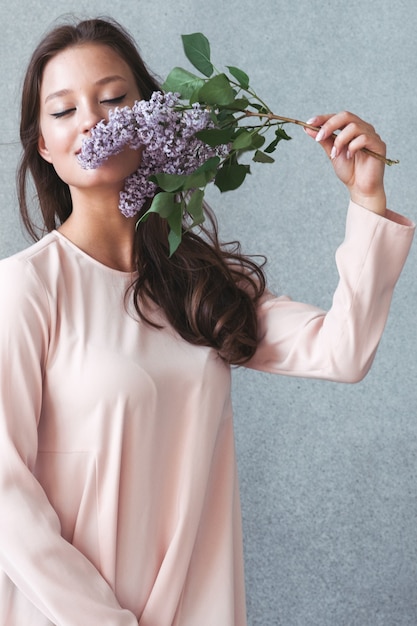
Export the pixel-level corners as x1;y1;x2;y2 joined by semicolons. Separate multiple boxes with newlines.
0;0;417;626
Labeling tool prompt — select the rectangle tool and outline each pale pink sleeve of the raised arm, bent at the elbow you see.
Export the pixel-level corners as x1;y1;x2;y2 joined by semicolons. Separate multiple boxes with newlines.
247;203;415;383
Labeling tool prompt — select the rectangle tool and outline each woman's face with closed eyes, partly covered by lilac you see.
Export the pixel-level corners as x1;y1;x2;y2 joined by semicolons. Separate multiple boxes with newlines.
38;44;141;193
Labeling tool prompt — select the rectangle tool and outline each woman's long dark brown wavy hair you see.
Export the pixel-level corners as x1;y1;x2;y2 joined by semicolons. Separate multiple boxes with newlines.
17;18;265;364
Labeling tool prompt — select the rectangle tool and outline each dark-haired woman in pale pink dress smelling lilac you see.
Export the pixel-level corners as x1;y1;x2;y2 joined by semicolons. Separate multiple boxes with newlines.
0;20;413;626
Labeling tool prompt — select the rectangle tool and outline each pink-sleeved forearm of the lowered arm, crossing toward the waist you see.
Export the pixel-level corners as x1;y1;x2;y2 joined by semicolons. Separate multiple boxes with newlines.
0;444;137;626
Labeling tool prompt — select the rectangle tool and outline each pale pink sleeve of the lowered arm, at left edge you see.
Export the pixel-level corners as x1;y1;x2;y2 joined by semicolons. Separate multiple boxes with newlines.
0;259;137;626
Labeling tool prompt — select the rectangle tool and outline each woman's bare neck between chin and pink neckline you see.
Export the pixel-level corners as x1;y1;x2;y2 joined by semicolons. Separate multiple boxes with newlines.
59;193;136;272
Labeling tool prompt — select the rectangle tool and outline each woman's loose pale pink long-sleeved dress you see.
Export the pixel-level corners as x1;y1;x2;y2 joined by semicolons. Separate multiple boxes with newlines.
0;204;413;626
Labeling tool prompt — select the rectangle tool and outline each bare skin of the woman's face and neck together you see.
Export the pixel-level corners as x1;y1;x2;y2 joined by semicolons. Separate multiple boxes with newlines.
39;44;140;271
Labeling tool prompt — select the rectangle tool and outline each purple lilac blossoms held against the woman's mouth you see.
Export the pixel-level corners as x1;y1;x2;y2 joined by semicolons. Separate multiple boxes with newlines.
78;91;221;217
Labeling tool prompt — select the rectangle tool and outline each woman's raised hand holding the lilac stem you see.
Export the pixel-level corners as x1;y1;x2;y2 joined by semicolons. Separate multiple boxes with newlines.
306;111;386;215
